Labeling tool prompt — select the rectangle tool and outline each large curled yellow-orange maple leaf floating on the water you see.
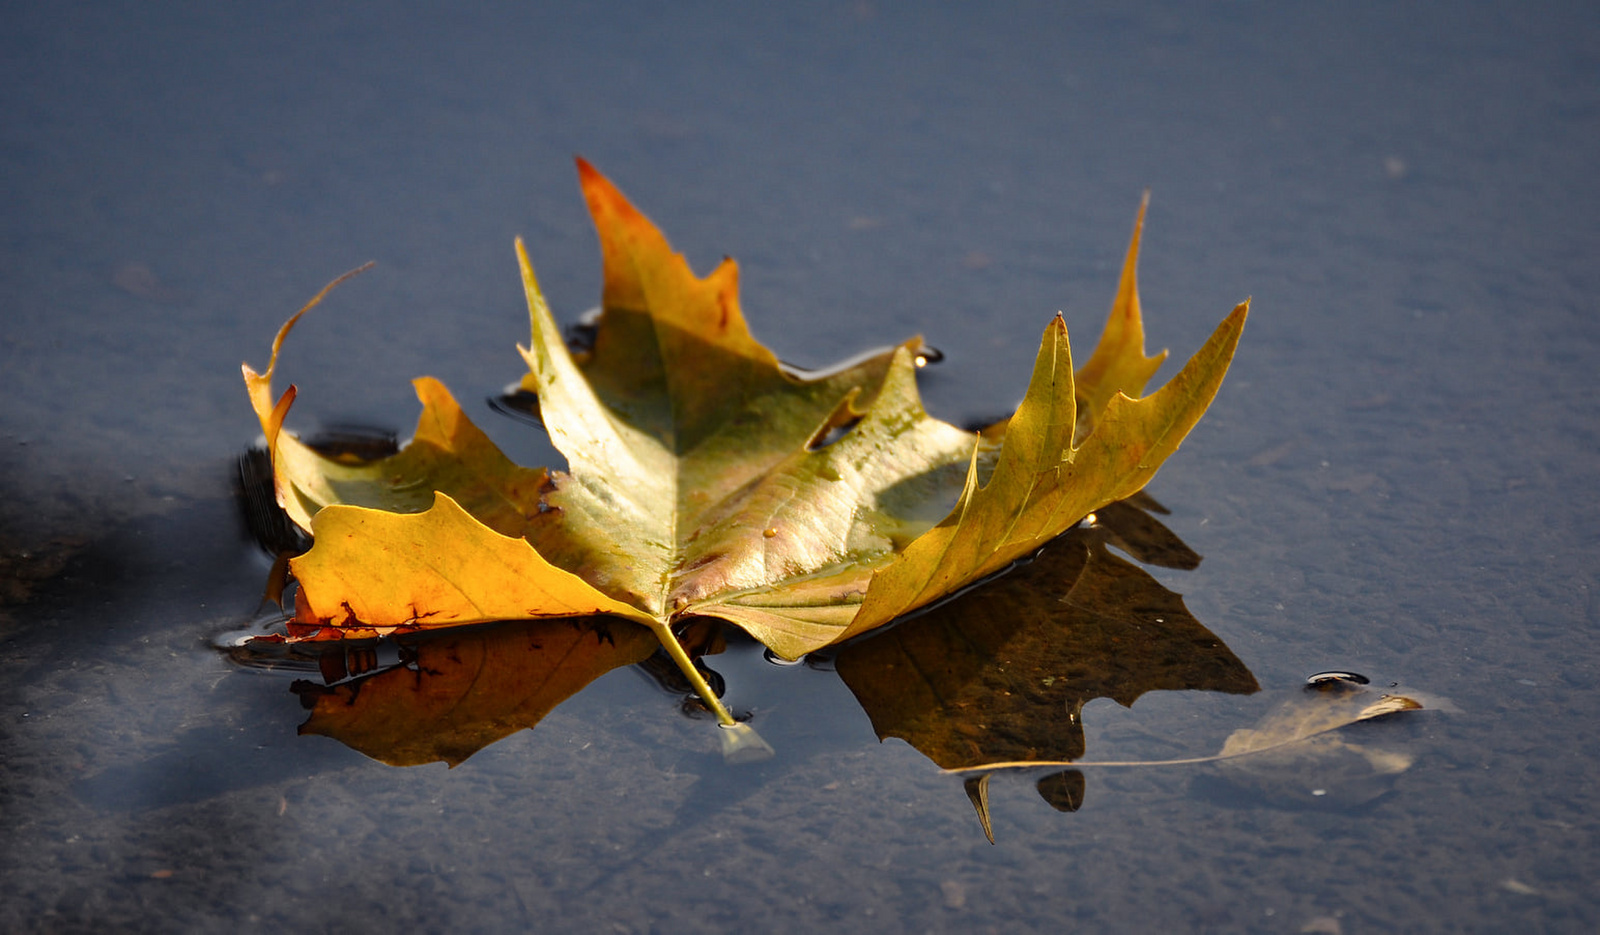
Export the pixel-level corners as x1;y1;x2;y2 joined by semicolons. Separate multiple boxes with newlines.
243;160;1248;736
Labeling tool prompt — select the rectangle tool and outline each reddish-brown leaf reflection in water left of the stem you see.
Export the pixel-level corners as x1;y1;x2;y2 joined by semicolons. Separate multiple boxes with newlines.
293;618;658;767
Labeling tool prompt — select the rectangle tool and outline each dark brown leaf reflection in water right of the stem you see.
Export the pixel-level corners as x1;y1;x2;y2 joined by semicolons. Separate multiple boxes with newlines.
835;521;1259;771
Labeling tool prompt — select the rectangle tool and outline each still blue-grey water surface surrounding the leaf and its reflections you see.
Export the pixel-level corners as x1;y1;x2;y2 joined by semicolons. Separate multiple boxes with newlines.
0;2;1600;932
